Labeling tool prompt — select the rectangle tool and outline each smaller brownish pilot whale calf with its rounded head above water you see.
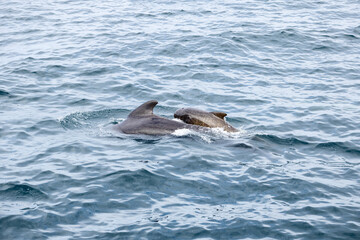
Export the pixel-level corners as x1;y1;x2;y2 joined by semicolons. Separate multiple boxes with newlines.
174;108;239;132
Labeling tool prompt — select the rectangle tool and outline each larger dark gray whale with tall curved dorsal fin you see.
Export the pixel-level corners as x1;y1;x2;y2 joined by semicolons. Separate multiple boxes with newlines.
116;100;203;135
